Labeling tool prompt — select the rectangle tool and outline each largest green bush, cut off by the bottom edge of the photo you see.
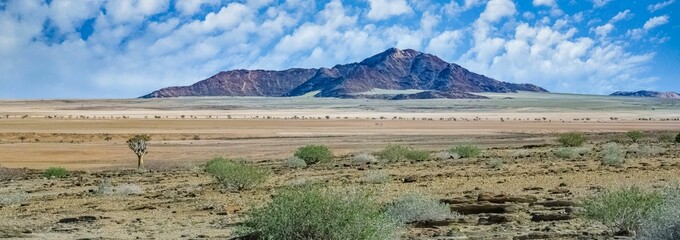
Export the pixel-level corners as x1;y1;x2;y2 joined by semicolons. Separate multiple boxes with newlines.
237;186;400;240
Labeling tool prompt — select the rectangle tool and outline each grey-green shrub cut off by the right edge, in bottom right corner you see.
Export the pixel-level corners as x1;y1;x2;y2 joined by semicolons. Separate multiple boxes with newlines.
639;188;680;240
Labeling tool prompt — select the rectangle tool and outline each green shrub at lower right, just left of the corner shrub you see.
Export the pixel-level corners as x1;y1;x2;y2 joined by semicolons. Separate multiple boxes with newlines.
583;187;662;235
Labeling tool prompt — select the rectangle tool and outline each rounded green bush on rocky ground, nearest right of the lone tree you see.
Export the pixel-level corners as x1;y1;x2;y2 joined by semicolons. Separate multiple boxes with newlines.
205;158;267;191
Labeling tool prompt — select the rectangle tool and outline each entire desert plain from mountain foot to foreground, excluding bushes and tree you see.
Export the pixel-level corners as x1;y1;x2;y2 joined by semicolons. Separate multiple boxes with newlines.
0;93;680;239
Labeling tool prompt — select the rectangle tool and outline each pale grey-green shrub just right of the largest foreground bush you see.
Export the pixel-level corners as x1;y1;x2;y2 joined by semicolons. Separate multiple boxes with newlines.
387;193;455;223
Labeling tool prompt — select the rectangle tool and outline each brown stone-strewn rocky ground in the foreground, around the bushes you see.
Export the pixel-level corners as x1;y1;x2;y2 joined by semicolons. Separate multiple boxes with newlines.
0;132;680;239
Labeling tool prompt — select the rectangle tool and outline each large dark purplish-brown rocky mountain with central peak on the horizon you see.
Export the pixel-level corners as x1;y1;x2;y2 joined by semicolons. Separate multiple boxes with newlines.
142;48;547;99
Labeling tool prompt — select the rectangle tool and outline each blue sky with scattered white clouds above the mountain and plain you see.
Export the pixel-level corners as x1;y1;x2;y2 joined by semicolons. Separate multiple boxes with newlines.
0;0;680;98
